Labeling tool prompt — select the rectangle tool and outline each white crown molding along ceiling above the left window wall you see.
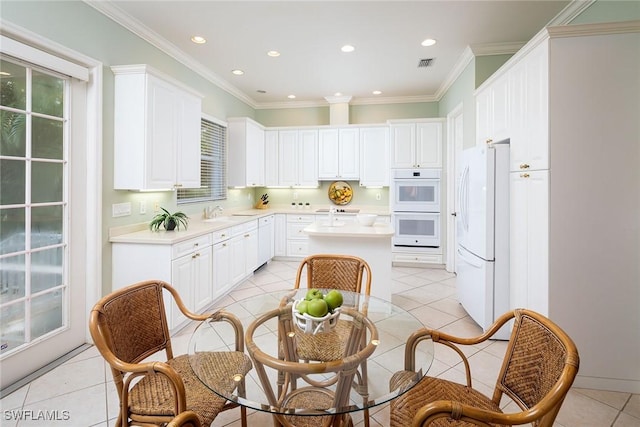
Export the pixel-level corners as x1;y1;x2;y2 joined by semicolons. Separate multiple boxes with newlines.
82;0;256;108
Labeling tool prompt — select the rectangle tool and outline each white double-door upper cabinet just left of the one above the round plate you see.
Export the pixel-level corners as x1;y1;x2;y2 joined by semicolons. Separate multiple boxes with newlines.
278;129;318;187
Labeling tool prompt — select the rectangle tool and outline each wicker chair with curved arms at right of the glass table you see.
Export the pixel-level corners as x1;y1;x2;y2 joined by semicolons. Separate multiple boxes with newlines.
390;309;580;427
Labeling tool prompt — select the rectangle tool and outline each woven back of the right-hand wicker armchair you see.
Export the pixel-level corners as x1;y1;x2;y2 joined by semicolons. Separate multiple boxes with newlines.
493;309;579;426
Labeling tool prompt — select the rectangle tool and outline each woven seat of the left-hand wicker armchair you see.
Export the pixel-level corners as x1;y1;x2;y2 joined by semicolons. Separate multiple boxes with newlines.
129;352;252;426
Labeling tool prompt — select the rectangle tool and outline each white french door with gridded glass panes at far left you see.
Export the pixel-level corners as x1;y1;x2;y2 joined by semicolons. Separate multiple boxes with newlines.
0;52;87;389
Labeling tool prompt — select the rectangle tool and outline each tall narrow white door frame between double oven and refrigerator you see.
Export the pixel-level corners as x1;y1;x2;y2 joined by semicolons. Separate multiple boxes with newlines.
445;103;464;272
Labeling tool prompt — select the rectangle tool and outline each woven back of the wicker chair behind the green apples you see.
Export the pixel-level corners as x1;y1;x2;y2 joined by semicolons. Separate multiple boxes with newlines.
294;254;371;295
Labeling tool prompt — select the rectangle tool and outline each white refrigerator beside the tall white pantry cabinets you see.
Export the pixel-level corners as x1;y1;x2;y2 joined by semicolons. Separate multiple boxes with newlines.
456;140;510;339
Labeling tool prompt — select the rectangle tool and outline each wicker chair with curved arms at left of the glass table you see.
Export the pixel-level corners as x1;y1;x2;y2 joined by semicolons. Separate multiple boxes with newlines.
89;281;251;427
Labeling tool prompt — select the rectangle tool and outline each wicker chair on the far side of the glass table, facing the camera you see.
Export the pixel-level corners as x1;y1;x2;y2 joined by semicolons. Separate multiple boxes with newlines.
294;254;371;427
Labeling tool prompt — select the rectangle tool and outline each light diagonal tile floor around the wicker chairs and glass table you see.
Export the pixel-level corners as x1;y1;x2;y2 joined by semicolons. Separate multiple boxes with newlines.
0;261;640;427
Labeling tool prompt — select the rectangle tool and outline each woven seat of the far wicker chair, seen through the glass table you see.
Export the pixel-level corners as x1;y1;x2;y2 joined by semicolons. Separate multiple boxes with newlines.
296;319;351;362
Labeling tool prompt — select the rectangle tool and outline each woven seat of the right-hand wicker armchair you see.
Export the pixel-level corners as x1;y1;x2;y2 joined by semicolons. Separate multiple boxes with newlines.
391;378;502;427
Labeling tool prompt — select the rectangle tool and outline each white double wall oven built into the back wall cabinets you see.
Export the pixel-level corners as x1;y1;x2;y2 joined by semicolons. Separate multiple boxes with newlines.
391;169;441;248
